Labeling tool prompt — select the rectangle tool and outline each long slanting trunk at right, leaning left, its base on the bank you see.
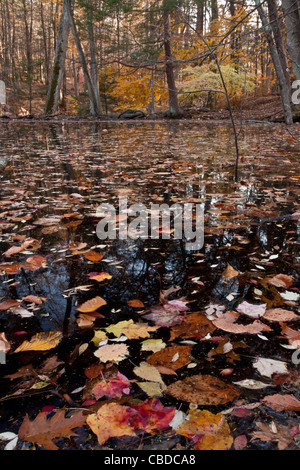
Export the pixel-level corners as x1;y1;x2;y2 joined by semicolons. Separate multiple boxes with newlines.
255;0;293;125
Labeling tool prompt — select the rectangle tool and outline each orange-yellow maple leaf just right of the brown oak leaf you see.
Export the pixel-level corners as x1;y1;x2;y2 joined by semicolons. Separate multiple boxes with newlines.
86;403;136;445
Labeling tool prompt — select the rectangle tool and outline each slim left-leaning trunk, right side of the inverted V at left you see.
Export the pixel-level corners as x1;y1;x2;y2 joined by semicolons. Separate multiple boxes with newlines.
65;0;100;116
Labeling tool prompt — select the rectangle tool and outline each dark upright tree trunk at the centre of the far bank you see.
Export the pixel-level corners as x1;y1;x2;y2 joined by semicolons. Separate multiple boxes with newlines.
163;5;180;116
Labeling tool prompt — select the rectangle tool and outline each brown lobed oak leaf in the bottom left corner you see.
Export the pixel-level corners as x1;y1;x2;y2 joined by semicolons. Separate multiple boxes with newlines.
19;410;86;450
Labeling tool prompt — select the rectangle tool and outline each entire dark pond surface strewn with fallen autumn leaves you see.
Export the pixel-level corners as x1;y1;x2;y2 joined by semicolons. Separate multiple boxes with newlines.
0;121;300;450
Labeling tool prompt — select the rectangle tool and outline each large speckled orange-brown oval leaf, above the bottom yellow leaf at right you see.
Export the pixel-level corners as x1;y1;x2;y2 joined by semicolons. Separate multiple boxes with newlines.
166;374;240;405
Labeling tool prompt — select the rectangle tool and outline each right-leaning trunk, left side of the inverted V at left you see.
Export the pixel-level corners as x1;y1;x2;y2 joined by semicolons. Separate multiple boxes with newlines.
45;0;70;114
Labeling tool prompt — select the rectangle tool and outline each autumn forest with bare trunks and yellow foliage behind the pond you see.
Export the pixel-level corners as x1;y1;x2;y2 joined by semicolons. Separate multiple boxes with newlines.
0;0;300;124
